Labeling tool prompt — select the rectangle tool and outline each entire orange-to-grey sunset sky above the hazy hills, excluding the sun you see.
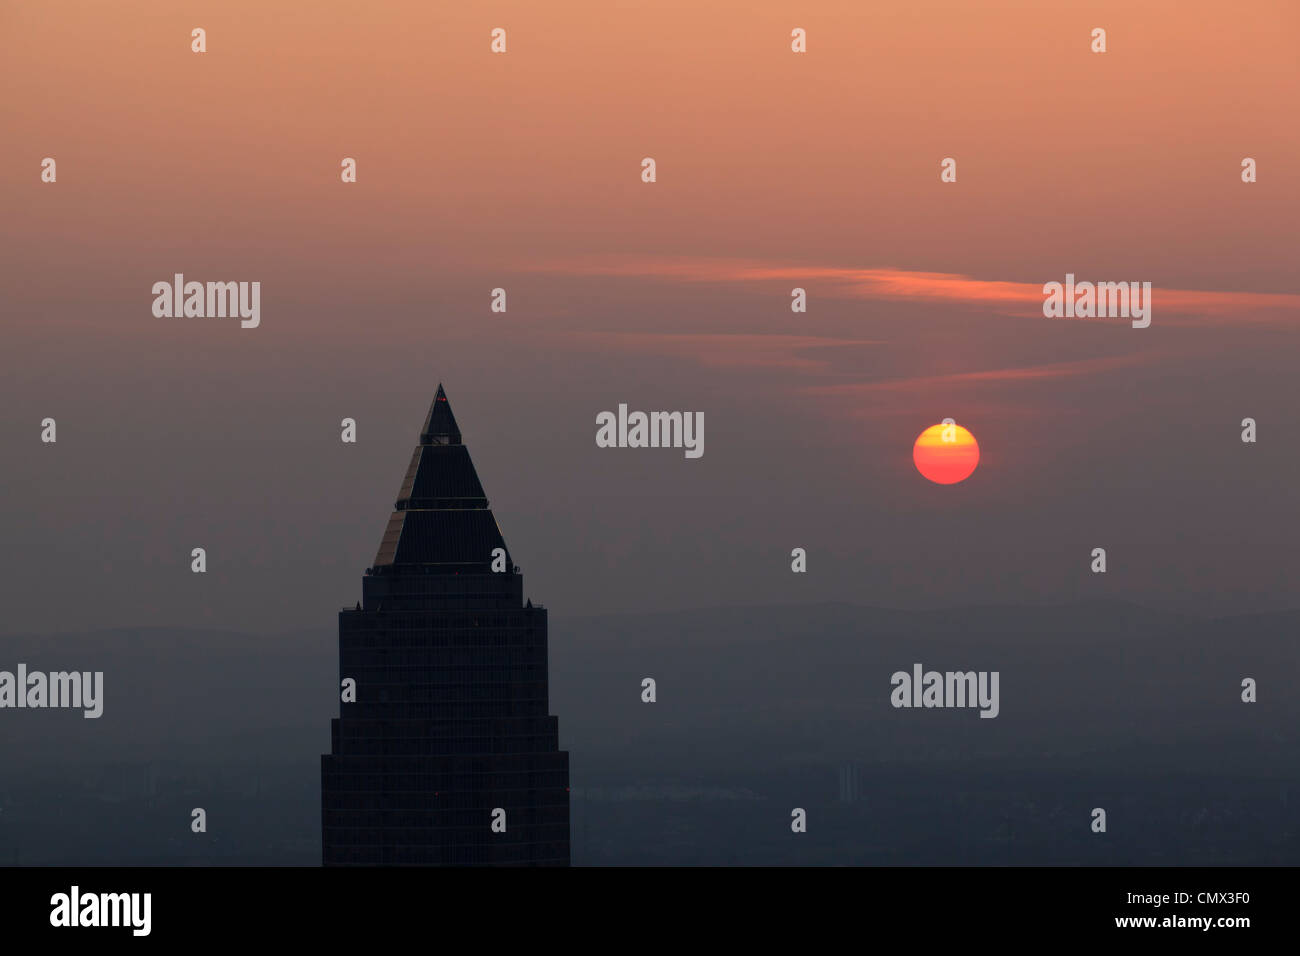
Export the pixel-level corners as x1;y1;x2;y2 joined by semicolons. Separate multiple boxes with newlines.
0;0;1300;632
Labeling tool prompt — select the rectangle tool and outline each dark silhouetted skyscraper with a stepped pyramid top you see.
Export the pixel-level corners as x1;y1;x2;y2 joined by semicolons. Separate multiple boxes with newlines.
321;385;569;866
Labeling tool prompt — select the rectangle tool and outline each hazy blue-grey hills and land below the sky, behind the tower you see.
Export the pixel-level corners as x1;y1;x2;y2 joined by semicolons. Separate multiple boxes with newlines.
0;602;1300;866
